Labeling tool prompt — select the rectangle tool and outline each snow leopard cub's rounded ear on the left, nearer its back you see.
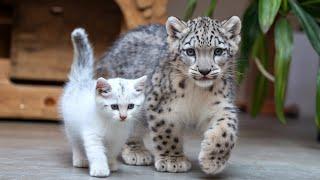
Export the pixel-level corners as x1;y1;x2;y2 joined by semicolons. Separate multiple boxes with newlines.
166;16;188;39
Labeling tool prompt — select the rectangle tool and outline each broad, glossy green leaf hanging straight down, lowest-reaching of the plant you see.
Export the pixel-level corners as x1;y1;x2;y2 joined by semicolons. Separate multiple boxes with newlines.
274;18;293;124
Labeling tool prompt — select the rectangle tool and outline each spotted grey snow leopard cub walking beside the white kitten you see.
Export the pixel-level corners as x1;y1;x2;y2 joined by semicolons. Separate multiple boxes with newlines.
96;16;241;174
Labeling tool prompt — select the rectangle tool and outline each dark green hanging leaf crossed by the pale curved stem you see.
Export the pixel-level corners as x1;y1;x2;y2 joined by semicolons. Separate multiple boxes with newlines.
250;34;268;116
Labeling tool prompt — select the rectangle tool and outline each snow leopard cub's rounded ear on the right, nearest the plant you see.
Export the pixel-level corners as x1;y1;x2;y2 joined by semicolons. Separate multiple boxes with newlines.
221;16;241;44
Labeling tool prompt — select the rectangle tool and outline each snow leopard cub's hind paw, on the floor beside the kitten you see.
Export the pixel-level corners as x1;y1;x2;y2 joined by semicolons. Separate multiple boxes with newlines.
121;145;152;166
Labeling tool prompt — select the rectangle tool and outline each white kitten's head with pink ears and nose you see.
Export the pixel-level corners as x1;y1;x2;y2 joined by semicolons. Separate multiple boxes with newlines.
96;76;147;122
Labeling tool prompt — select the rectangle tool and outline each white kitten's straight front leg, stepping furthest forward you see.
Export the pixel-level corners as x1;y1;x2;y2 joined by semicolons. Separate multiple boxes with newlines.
83;133;110;177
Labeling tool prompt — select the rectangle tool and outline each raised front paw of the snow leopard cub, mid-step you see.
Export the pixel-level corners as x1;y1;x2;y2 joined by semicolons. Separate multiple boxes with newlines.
199;132;234;174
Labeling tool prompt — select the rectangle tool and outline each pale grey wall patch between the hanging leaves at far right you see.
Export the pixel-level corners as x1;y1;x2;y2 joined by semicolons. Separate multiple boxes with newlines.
287;32;320;117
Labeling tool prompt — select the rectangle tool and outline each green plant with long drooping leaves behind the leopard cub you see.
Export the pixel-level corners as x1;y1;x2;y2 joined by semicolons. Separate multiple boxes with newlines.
184;0;320;130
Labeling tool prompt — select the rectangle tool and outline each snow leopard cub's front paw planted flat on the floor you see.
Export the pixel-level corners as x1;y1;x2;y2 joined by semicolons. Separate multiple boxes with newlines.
154;156;191;172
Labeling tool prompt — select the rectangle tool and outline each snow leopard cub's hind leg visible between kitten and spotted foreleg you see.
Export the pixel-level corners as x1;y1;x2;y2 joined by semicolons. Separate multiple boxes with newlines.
121;121;153;166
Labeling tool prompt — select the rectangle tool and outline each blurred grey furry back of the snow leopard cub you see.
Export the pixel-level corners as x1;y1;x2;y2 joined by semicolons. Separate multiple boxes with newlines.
96;25;168;78
